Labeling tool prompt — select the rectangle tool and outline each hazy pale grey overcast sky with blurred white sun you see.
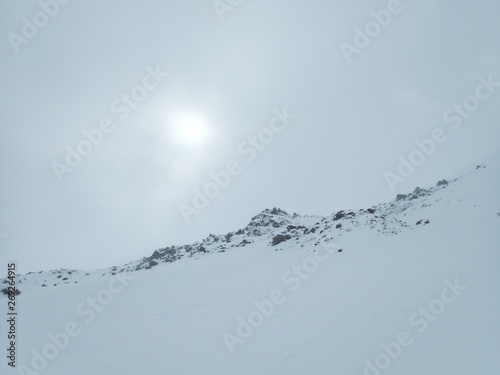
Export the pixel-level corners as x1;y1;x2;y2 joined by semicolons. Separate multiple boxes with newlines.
0;0;500;275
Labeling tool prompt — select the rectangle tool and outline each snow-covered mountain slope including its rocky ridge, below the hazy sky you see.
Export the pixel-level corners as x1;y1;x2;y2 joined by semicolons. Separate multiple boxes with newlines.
0;155;500;375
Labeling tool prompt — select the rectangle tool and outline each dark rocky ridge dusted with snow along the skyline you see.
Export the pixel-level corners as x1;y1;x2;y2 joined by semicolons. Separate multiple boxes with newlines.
0;154;491;288
